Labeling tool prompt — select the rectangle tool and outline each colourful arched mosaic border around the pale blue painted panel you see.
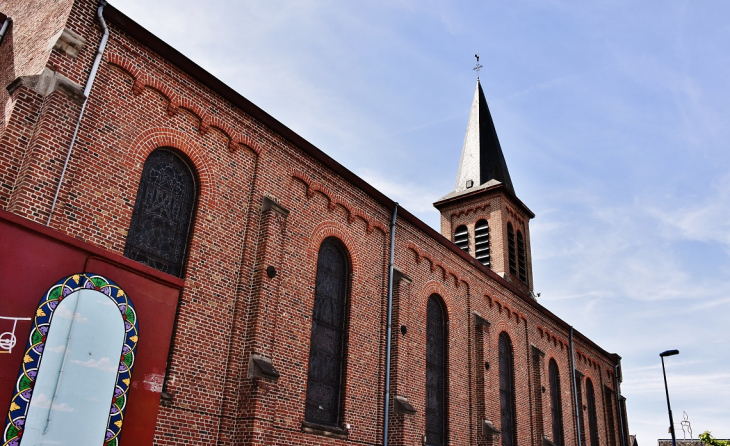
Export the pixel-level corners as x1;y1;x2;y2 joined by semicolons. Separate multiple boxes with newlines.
1;273;139;446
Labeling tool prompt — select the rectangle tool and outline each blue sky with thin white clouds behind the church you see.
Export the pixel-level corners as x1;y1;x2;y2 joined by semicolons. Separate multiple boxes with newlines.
112;0;730;445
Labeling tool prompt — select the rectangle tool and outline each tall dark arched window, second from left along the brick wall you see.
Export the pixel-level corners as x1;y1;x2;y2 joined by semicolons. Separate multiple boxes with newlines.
304;237;350;427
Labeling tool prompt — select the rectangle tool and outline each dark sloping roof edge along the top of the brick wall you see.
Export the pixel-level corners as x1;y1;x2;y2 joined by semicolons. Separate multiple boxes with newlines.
104;4;611;362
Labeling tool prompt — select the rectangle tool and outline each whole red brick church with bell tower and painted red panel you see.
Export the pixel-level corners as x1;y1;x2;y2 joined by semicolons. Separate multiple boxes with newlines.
0;0;629;446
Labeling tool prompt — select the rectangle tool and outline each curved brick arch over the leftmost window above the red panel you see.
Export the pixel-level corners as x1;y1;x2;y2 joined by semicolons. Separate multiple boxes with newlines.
127;128;215;209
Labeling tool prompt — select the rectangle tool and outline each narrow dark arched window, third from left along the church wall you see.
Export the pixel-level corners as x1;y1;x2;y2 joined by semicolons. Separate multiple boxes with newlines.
426;294;446;446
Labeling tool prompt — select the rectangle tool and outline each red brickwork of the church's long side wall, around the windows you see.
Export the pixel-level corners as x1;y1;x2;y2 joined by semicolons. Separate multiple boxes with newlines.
0;0;614;445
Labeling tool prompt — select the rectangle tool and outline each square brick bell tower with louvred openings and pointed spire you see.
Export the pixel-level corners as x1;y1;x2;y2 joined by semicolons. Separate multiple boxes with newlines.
434;79;535;296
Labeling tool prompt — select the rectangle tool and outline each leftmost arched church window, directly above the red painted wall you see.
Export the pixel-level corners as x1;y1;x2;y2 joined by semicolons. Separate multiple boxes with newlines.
124;149;197;277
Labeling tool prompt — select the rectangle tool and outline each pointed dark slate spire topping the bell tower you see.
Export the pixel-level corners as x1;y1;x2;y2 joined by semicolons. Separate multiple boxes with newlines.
449;79;515;195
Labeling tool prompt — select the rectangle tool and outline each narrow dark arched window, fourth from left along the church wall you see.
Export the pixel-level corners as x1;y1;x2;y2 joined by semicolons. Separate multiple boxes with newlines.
499;332;517;446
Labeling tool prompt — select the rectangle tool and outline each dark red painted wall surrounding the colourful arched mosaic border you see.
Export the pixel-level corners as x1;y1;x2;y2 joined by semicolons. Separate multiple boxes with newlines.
0;211;182;445
